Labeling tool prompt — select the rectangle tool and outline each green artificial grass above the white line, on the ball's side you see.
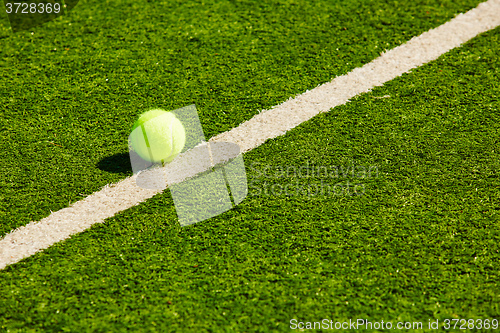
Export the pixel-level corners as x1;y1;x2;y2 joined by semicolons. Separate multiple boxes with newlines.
0;0;480;236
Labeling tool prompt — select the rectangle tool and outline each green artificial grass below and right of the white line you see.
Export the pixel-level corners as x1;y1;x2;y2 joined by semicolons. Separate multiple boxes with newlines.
0;20;500;332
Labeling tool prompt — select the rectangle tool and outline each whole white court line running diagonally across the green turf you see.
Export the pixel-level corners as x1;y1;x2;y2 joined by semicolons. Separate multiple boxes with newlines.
0;0;500;269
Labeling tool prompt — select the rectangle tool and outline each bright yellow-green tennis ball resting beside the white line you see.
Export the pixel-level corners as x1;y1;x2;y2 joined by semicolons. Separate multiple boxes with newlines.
130;109;186;162
